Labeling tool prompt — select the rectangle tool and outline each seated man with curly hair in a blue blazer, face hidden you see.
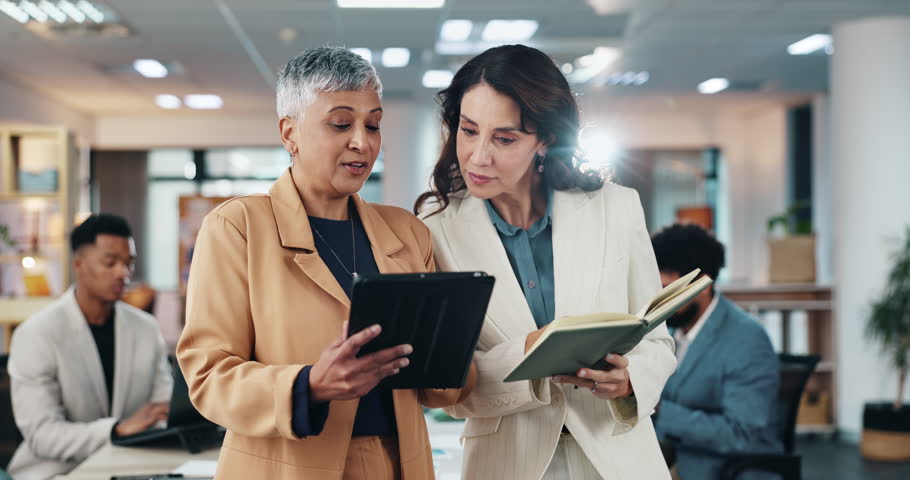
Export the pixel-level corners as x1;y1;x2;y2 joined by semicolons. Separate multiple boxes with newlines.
652;225;783;480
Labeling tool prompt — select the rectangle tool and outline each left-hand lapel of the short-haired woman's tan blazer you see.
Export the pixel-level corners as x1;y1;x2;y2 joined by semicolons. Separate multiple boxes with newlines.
269;169;351;306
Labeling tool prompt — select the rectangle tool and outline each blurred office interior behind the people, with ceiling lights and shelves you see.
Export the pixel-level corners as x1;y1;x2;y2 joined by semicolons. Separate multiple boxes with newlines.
0;0;910;478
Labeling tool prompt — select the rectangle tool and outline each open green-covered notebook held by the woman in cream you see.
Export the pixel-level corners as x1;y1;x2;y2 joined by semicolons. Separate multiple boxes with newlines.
505;269;711;382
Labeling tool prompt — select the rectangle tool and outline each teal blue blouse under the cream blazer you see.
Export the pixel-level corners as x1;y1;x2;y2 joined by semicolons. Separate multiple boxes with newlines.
485;190;556;327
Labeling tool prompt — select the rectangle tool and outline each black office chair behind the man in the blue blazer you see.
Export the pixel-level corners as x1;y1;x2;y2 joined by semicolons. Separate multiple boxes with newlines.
720;353;821;480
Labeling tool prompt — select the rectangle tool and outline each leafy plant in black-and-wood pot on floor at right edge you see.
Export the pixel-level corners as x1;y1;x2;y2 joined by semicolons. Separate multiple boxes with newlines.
860;228;910;461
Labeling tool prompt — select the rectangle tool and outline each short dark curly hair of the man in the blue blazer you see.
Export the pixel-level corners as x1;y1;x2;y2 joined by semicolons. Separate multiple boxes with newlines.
651;224;726;280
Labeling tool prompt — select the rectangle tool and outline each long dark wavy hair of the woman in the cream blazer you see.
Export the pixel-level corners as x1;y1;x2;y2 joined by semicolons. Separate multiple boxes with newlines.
414;45;604;214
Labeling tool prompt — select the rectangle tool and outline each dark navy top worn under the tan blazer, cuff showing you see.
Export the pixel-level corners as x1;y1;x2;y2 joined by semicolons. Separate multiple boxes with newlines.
292;208;398;436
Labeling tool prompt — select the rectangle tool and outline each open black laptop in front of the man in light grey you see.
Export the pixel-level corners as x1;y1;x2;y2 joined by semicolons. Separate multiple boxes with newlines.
112;362;224;453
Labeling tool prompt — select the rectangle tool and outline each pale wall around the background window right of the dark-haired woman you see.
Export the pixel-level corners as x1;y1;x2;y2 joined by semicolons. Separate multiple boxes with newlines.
582;100;787;283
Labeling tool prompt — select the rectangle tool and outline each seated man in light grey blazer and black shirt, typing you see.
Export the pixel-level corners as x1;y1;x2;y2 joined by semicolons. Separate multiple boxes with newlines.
9;214;173;480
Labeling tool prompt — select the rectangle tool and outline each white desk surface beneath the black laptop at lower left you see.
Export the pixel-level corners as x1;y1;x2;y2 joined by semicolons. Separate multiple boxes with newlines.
56;445;219;480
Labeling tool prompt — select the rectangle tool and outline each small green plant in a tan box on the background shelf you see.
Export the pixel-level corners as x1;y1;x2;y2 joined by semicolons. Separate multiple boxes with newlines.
768;202;815;283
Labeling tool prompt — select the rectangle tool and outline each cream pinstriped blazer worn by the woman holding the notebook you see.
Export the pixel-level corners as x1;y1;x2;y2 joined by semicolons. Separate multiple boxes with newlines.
422;184;676;480
